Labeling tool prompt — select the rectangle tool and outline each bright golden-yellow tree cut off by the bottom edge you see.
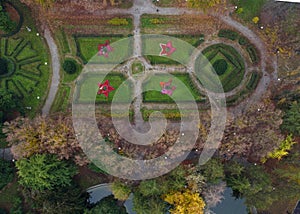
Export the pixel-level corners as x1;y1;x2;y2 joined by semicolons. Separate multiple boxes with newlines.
163;190;205;214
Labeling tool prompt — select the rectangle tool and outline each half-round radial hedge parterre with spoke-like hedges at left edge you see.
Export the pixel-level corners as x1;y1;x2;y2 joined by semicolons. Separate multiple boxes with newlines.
0;38;42;99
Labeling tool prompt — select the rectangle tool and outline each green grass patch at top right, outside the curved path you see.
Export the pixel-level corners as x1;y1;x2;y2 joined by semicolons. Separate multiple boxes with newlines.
231;0;267;22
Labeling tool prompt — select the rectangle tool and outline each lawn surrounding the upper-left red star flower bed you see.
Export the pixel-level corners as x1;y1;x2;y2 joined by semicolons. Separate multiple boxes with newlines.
74;35;132;64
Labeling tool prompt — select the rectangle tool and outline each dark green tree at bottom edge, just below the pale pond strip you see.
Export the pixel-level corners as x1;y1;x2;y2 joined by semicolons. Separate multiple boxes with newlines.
84;196;127;214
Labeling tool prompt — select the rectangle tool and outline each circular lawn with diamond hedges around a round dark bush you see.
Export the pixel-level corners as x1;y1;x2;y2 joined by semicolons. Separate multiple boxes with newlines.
196;44;245;92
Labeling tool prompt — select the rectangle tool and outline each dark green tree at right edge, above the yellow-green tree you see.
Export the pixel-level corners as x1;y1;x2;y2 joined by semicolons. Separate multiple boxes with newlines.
281;102;300;136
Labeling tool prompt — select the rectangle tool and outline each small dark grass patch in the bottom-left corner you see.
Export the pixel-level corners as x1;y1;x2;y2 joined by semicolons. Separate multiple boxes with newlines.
0;178;21;211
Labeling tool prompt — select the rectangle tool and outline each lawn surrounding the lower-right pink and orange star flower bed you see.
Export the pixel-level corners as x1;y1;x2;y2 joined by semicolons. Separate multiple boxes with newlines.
143;73;203;103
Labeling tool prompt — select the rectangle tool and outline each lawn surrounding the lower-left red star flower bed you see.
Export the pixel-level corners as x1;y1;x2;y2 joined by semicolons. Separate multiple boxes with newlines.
76;73;133;103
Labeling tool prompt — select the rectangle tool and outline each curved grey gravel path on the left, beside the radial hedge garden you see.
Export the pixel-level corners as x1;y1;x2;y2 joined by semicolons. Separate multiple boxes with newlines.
42;28;60;116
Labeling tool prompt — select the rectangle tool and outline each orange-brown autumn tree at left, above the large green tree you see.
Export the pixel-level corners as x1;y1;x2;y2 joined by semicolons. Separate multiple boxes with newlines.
4;116;88;165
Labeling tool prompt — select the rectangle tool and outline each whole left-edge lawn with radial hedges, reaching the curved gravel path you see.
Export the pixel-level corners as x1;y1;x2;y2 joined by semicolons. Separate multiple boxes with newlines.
0;1;50;116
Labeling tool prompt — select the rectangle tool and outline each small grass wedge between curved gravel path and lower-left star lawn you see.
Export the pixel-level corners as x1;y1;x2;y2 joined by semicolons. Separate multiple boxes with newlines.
51;85;71;113
